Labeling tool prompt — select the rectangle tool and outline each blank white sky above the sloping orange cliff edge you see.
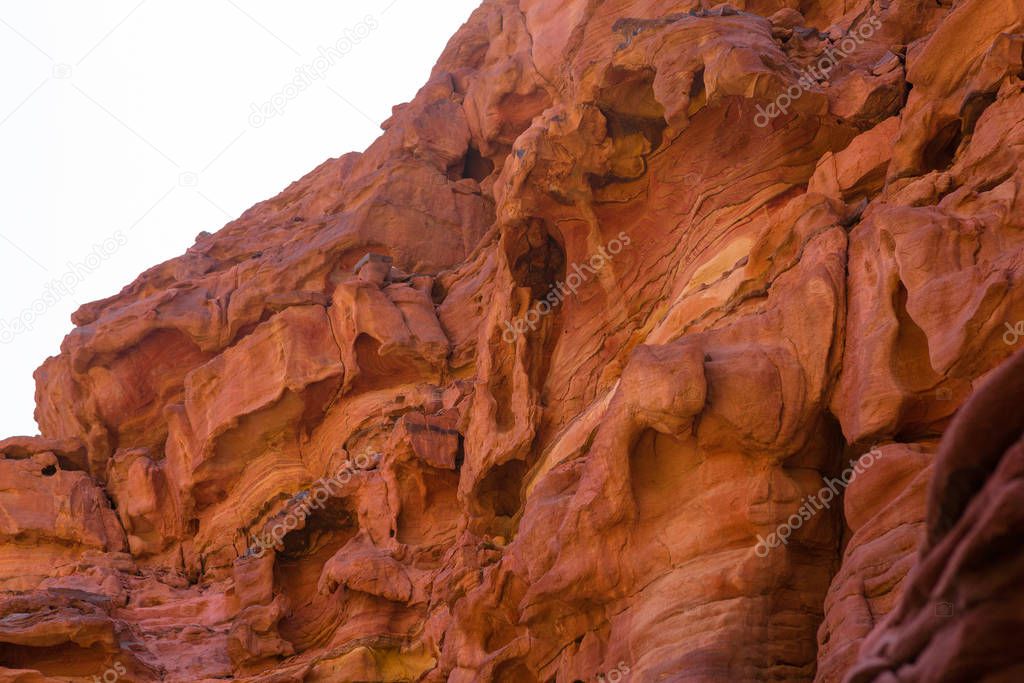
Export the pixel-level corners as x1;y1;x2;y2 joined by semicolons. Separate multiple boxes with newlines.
0;0;480;438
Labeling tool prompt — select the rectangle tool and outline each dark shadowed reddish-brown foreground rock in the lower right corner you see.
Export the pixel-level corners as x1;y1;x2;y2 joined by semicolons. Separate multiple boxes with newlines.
848;352;1024;683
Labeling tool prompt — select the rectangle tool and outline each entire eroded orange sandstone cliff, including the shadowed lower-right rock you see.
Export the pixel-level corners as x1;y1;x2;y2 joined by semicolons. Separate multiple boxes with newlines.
0;0;1024;683
